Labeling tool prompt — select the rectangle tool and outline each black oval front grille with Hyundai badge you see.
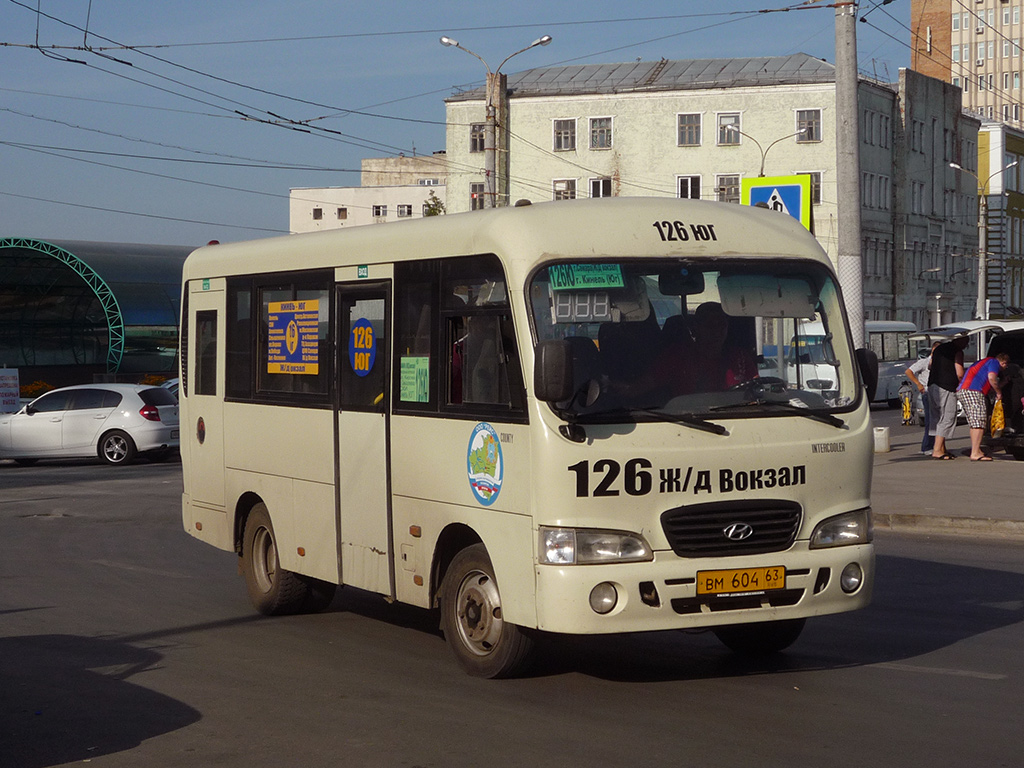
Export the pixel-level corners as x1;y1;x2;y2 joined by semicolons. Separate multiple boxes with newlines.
662;500;801;557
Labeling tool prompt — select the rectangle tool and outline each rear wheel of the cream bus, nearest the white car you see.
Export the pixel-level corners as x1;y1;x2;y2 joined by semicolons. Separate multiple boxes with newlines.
242;503;311;616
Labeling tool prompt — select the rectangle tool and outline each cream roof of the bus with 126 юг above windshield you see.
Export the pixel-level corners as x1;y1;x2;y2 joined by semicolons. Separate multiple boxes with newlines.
183;198;830;283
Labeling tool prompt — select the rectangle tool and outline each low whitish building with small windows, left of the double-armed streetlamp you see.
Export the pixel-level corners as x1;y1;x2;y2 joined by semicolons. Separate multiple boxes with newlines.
288;153;447;233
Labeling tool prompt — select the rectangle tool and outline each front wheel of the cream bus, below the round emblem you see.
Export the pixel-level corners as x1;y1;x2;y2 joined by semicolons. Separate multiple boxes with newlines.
440;544;535;679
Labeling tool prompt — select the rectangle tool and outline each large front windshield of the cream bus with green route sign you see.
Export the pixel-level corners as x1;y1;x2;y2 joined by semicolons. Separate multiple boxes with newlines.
529;259;858;422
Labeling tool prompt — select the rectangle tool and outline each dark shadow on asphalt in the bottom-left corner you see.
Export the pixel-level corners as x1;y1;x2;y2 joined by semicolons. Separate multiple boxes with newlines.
0;635;201;768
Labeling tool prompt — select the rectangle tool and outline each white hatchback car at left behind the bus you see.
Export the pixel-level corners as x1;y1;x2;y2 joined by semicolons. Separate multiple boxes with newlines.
0;384;179;464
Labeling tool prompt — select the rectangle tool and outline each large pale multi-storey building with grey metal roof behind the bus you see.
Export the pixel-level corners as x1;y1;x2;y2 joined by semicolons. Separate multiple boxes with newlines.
445;54;979;327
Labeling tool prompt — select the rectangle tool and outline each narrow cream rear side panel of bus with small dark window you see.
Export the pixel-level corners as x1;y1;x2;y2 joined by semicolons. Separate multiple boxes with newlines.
186;281;224;508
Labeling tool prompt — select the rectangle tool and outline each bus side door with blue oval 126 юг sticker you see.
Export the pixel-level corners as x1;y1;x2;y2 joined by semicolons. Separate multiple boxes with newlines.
336;283;394;595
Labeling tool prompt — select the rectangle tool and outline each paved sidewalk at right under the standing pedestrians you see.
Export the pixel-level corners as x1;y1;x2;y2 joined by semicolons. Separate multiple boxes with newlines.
871;410;1024;542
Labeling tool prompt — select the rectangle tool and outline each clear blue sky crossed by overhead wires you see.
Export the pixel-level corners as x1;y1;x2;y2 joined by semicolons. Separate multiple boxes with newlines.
0;0;910;245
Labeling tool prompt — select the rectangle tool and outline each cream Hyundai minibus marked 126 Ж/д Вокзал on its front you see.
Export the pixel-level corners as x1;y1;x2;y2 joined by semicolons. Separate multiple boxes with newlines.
180;199;874;677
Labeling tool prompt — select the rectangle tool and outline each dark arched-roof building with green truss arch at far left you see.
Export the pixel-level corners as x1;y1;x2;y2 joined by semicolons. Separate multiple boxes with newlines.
0;238;193;374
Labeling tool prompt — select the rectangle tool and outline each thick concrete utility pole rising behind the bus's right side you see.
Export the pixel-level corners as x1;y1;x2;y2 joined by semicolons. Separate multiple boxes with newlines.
836;2;864;348
